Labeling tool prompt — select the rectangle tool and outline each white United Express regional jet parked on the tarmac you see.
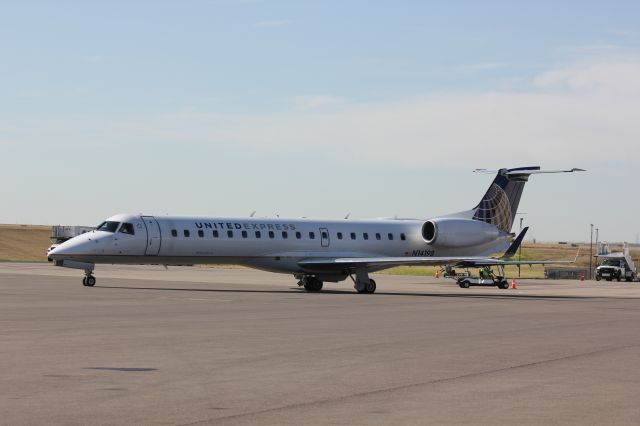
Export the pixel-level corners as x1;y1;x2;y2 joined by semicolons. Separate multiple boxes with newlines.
49;167;582;293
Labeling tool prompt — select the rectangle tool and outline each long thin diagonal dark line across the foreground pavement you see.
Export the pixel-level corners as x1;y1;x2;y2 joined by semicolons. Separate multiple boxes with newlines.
180;344;640;426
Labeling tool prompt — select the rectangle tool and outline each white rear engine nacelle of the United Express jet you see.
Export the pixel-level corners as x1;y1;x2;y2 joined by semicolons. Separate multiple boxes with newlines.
422;217;500;247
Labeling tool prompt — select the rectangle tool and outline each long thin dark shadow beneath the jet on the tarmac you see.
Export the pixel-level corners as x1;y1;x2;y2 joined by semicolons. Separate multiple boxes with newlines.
94;285;618;300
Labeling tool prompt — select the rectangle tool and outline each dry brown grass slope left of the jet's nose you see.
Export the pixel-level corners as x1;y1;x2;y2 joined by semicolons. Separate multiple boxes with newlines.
0;225;51;262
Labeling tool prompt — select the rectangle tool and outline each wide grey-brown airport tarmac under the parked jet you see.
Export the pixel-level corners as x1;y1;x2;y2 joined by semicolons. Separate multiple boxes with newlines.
0;263;640;425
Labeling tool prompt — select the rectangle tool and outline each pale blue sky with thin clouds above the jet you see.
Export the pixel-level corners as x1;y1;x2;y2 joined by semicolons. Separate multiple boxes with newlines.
0;0;640;242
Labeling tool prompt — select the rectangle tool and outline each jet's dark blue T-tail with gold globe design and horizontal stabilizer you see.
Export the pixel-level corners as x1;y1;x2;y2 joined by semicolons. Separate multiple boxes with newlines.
472;166;584;232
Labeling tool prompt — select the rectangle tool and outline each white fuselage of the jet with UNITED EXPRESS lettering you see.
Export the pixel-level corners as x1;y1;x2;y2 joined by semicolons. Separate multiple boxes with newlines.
50;214;506;273
